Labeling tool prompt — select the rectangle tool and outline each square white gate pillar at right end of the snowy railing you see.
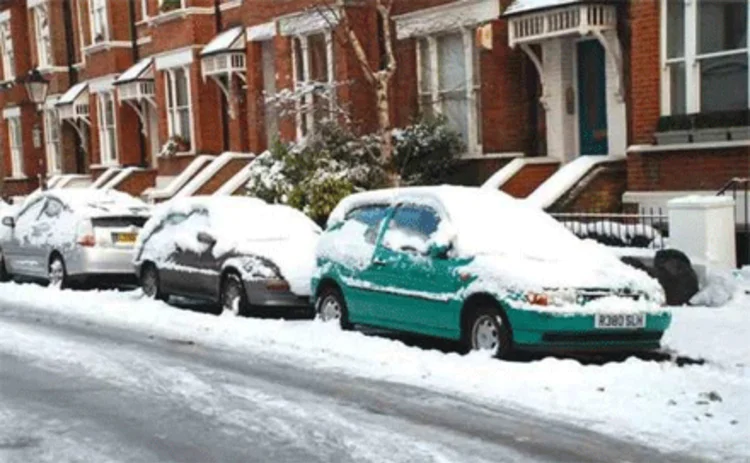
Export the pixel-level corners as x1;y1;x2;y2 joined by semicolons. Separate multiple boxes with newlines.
667;196;737;269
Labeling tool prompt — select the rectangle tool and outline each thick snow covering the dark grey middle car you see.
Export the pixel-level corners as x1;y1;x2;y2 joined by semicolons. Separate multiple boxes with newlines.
136;196;320;295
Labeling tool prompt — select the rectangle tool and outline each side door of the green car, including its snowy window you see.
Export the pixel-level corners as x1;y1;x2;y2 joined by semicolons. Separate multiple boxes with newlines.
366;204;460;335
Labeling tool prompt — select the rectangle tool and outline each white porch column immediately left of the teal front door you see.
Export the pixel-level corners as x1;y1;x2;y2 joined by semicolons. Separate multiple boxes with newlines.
542;39;578;163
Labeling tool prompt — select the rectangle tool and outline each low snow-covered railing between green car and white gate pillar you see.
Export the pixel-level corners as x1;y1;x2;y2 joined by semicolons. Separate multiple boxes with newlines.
551;209;669;249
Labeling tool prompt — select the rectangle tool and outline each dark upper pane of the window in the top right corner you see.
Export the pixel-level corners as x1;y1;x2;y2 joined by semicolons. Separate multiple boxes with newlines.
698;0;747;53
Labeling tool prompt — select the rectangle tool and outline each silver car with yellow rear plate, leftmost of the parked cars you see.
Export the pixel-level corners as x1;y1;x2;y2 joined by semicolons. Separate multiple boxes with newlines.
0;189;150;287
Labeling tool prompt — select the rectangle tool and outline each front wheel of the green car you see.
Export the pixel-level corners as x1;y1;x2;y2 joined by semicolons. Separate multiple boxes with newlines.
463;305;513;359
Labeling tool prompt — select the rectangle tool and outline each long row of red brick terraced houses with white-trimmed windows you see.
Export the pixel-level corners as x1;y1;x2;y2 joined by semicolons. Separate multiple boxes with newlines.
0;0;750;215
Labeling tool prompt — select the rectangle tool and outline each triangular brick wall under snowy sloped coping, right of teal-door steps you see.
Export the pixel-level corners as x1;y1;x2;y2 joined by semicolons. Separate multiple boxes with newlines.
548;161;627;213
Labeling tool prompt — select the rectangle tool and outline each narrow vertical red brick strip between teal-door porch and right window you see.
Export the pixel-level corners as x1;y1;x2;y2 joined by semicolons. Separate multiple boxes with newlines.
630;0;661;144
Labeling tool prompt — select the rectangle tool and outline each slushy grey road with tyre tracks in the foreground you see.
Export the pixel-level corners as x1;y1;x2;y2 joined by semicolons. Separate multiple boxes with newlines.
0;304;684;463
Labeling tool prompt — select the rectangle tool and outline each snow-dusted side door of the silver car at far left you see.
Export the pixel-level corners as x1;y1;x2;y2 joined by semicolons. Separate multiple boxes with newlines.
5;197;47;277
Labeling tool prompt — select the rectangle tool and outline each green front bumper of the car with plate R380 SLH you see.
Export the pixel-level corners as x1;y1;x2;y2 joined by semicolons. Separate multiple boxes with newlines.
508;310;671;352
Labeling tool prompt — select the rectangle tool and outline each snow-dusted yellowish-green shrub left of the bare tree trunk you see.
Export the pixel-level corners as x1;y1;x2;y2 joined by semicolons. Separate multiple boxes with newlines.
247;122;386;223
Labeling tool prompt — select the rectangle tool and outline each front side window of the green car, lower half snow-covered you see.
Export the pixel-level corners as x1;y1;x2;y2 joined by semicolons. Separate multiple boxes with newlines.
383;205;440;253
